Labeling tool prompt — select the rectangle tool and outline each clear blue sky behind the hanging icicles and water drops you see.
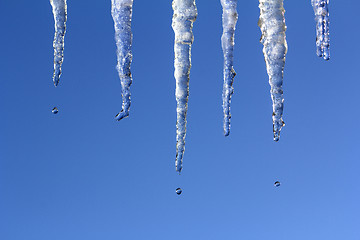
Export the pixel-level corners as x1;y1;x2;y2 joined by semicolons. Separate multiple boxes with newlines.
0;0;360;240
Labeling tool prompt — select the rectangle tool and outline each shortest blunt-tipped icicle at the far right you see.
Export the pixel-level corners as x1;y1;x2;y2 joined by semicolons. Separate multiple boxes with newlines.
311;0;330;60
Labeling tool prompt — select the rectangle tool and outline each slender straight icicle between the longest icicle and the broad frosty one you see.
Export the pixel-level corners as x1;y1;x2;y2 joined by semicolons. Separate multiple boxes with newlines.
221;0;238;136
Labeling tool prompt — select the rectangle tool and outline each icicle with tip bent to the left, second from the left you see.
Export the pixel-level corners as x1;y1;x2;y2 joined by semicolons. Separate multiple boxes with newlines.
111;0;133;121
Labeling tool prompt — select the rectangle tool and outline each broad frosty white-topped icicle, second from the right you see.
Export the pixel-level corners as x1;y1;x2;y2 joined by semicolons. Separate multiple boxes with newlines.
258;0;287;141
